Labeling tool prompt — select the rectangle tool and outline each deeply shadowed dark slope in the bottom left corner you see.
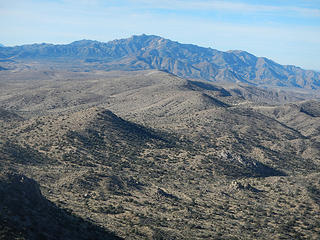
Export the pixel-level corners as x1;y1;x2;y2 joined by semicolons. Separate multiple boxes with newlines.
0;171;121;240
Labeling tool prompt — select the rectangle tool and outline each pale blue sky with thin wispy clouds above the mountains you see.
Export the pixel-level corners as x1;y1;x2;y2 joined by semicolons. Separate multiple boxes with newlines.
0;0;320;71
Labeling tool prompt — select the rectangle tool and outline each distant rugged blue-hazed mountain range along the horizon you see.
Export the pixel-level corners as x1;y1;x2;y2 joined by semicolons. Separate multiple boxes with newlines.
0;35;320;89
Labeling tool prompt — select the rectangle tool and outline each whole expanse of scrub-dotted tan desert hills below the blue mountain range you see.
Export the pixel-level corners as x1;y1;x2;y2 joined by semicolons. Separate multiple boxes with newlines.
0;66;320;239
